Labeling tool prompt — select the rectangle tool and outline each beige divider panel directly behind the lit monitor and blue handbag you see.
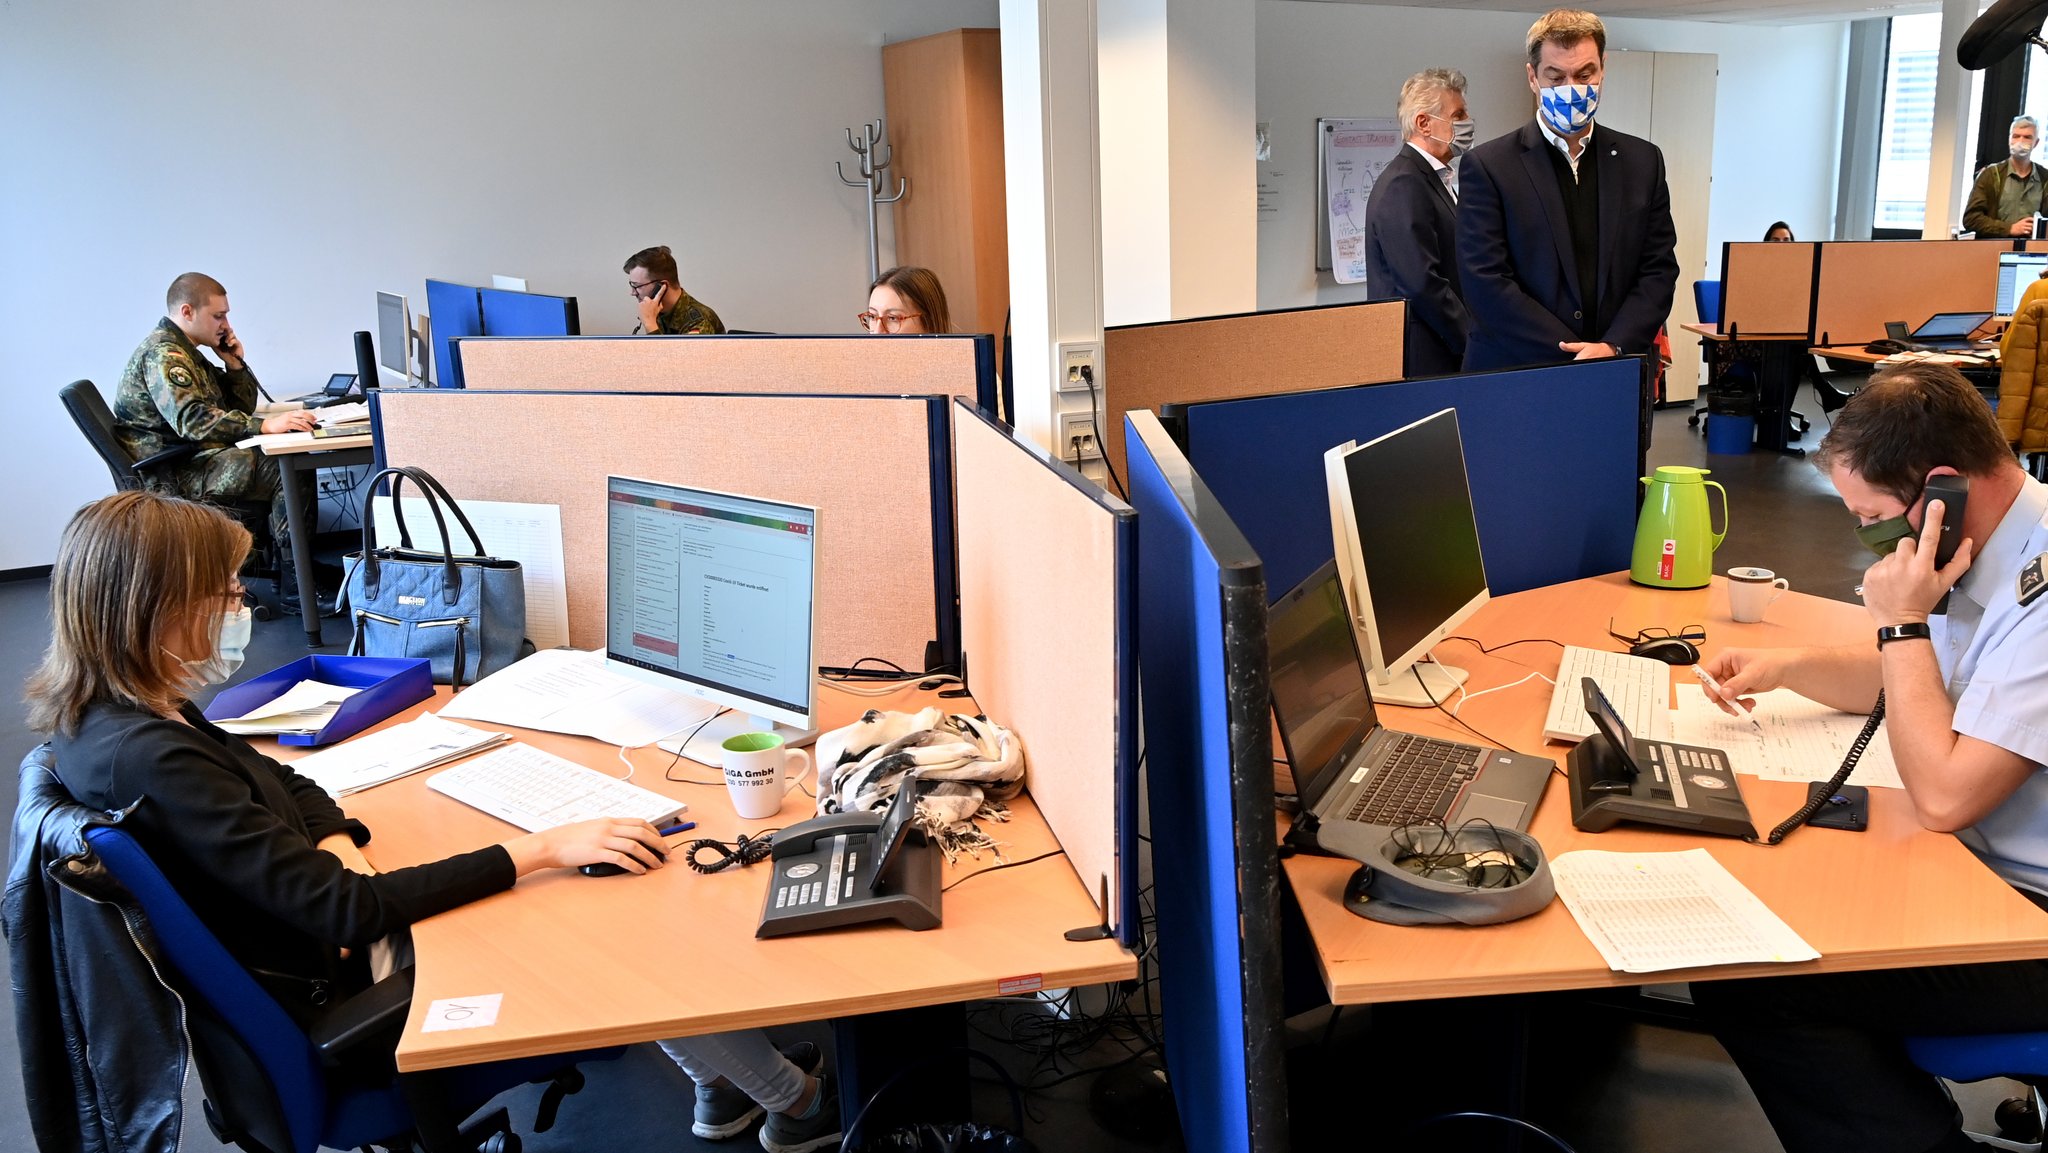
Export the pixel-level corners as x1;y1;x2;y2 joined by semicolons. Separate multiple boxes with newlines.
371;389;958;670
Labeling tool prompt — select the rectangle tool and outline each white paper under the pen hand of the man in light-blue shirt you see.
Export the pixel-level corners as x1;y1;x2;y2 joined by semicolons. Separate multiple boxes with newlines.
1671;682;1901;788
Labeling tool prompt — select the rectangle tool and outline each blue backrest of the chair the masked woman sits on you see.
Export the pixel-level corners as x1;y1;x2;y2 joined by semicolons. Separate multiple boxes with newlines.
86;835;328;1149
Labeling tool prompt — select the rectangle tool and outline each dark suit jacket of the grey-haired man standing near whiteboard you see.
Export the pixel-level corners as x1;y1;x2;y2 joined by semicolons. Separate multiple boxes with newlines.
1366;143;1468;377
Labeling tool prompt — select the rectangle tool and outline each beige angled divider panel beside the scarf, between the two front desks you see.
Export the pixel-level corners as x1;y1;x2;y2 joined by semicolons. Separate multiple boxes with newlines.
952;401;1139;944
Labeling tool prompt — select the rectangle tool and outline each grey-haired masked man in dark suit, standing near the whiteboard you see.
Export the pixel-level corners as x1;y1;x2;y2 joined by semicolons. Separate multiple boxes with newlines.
1366;68;1473;379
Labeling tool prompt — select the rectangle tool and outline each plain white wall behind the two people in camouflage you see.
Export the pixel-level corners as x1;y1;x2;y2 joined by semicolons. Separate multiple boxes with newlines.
0;0;995;571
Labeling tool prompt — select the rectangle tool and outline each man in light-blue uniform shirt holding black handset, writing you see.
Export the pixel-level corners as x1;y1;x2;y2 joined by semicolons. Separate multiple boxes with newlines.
1694;365;2048;1153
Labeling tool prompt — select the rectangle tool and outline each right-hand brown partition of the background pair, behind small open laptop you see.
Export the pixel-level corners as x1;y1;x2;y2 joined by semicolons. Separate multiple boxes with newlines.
1812;240;2013;344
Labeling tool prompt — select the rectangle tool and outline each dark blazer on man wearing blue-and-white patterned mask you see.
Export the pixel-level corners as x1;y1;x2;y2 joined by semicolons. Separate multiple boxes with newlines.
1458;121;1677;371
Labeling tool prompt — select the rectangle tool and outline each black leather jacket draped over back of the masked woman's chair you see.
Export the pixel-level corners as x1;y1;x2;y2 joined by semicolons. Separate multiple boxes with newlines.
0;745;193;1153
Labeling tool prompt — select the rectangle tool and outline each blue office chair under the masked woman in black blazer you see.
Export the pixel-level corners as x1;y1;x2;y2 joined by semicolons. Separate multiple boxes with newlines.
20;745;623;1153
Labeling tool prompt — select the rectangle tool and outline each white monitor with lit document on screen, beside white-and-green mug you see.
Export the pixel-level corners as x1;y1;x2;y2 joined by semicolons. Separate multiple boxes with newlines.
604;477;817;764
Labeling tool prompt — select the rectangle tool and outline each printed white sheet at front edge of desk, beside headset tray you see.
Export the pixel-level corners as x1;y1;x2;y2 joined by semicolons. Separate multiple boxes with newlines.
1550;848;1821;973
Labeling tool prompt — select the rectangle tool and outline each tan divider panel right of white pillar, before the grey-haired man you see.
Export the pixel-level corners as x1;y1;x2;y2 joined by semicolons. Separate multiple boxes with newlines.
1102;301;1407;479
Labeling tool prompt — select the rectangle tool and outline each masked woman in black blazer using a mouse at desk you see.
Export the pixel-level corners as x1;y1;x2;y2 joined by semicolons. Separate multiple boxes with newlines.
27;492;838;1153
